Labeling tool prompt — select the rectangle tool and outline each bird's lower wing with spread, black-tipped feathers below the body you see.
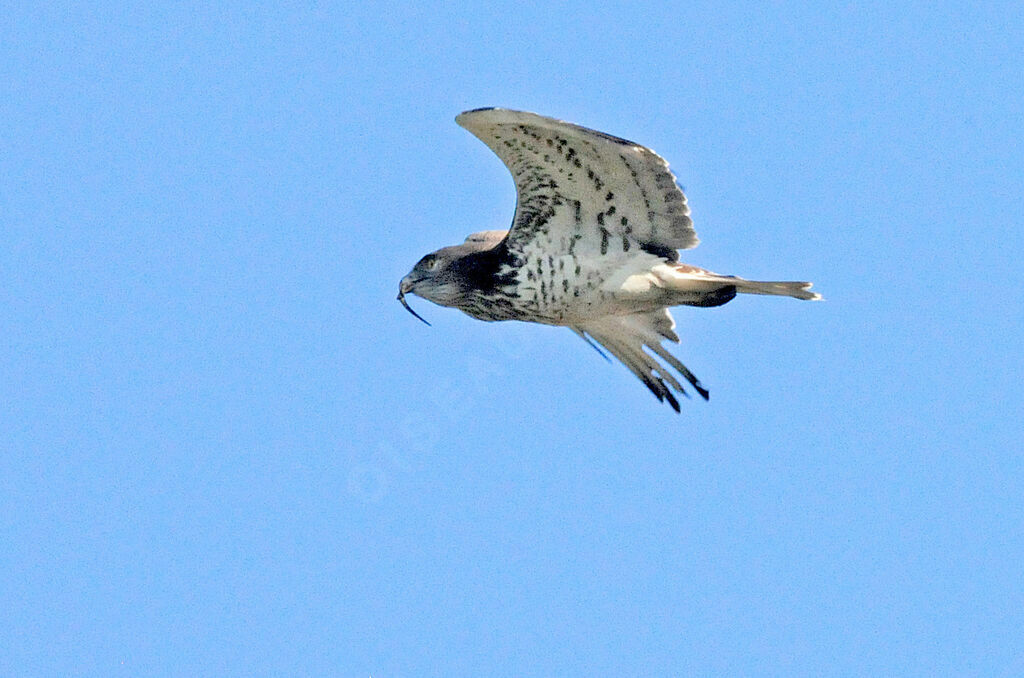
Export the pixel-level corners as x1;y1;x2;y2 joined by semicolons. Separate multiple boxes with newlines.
572;308;708;412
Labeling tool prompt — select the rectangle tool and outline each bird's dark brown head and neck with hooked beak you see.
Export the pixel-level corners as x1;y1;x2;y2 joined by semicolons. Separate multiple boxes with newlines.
398;230;507;325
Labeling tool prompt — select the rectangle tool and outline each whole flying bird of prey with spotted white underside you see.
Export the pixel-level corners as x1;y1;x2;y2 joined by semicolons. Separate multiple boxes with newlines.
398;109;821;412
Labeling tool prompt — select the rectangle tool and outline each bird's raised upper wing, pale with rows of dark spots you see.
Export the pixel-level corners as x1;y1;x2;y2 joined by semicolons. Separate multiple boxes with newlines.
456;109;699;259
